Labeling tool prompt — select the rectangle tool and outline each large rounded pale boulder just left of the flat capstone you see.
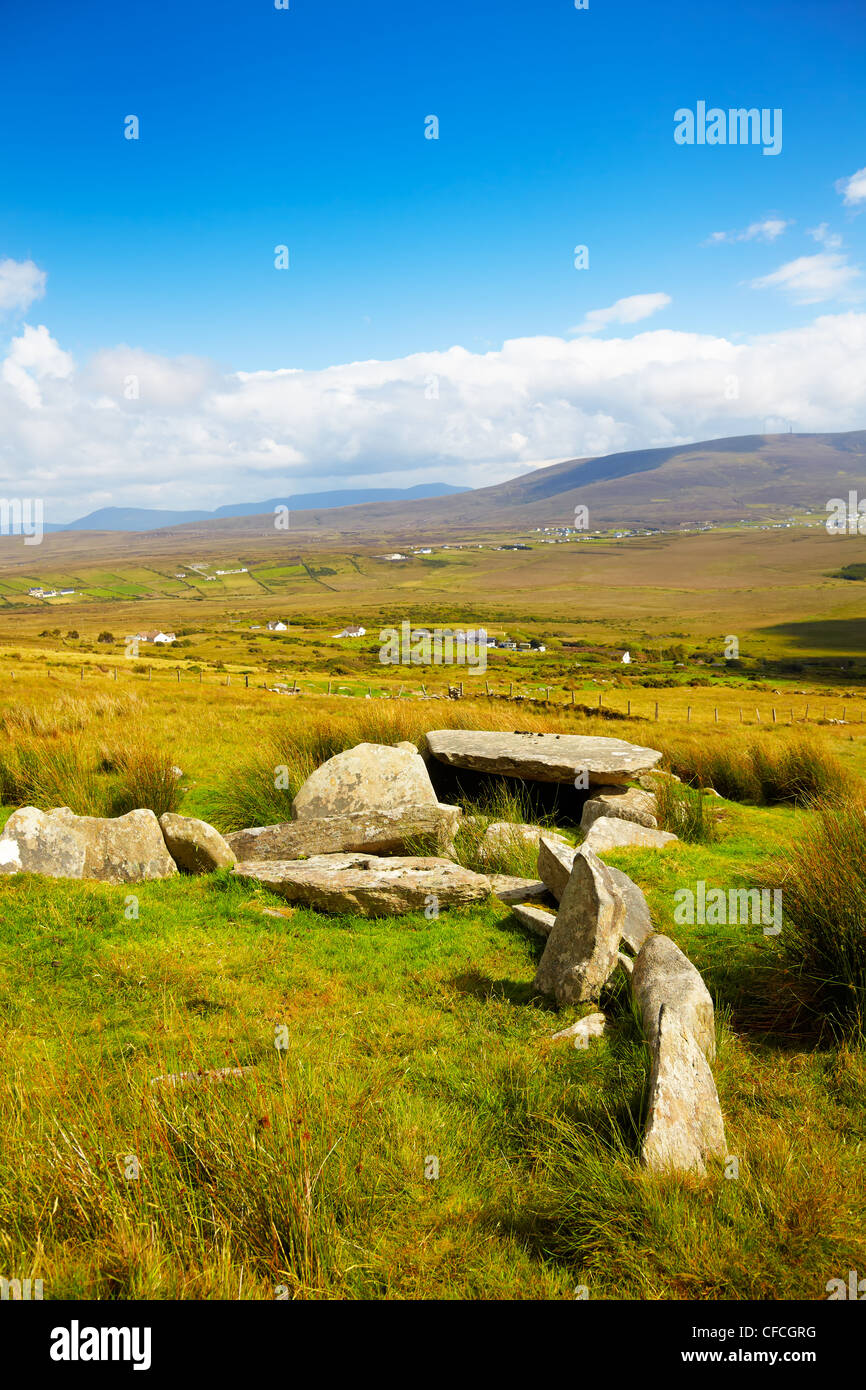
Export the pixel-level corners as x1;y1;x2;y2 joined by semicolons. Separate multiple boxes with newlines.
292;744;438;820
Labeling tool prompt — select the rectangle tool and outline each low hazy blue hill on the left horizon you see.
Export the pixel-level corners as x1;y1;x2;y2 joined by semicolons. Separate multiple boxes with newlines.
44;482;471;531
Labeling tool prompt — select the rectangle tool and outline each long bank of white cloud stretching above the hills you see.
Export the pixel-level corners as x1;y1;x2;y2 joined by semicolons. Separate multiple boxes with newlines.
0;311;866;521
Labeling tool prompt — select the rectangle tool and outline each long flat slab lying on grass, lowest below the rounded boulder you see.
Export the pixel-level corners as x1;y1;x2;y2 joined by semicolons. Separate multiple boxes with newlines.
232;855;491;917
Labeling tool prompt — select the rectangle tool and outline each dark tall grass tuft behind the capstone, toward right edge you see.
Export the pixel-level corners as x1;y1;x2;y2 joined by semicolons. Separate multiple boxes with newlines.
660;735;851;806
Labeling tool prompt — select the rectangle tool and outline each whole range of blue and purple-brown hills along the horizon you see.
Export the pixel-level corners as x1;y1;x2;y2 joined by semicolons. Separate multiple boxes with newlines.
23;430;866;553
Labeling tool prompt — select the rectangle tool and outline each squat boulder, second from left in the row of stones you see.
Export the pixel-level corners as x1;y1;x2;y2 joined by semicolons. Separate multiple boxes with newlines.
49;806;178;883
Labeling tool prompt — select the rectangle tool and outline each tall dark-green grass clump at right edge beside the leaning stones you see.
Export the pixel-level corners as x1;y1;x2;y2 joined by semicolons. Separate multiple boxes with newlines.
776;796;866;1038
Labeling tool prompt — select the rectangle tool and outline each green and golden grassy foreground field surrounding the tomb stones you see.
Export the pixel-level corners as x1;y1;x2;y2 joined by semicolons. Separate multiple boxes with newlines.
0;667;866;1300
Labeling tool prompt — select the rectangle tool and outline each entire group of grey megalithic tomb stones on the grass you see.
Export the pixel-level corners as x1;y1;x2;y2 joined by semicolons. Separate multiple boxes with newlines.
0;730;724;1173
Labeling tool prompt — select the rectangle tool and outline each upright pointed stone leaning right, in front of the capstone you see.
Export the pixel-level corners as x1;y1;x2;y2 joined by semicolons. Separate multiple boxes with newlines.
535;848;626;1005
